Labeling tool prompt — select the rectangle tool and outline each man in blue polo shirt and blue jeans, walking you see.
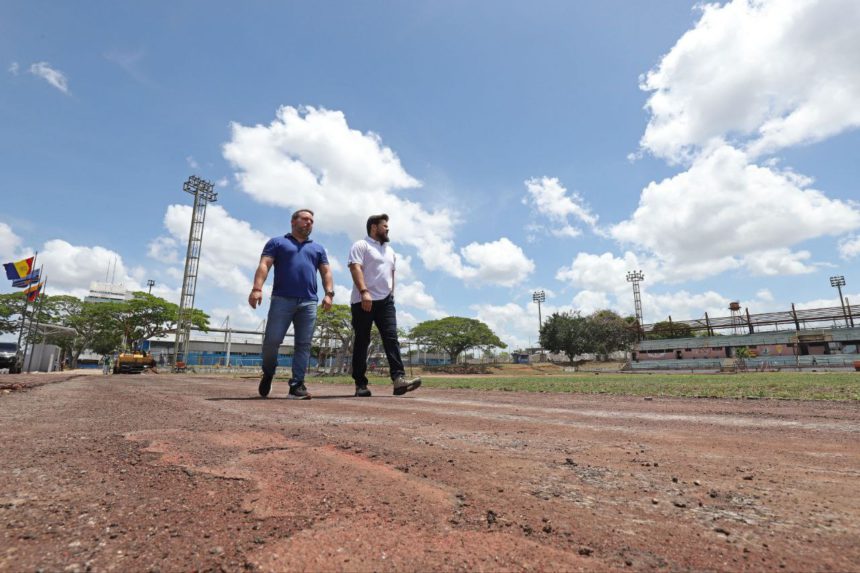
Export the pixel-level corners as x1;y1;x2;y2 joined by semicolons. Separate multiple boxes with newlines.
248;209;334;400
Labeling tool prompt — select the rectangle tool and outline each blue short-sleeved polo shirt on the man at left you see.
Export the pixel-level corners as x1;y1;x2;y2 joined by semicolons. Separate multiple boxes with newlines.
262;233;328;300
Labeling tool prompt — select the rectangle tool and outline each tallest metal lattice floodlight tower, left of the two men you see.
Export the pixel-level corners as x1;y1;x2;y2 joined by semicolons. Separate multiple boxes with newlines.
173;175;218;366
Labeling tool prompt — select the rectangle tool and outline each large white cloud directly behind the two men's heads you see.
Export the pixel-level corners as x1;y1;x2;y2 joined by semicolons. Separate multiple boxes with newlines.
224;106;532;284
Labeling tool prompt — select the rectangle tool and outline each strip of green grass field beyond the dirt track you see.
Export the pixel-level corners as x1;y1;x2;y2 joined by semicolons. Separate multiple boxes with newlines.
308;372;860;401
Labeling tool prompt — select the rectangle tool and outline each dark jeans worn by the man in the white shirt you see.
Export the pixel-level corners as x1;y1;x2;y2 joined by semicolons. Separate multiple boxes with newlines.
350;295;406;386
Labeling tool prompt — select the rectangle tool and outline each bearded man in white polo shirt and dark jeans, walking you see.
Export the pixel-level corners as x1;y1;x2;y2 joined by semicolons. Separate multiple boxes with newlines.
348;213;421;397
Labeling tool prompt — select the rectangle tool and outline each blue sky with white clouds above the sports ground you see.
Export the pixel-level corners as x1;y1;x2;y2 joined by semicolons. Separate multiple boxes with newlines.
0;0;860;346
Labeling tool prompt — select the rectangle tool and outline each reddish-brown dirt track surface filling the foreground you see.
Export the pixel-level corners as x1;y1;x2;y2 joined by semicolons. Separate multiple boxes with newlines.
0;372;860;572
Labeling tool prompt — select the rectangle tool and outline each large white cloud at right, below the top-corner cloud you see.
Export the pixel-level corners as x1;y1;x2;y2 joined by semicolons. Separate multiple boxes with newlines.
610;145;860;278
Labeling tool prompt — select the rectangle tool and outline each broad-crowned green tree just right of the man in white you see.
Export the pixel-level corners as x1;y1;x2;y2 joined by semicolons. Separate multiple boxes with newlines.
409;316;508;362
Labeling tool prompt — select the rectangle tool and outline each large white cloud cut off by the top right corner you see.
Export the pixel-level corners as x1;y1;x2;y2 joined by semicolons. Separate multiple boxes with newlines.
640;0;860;162
